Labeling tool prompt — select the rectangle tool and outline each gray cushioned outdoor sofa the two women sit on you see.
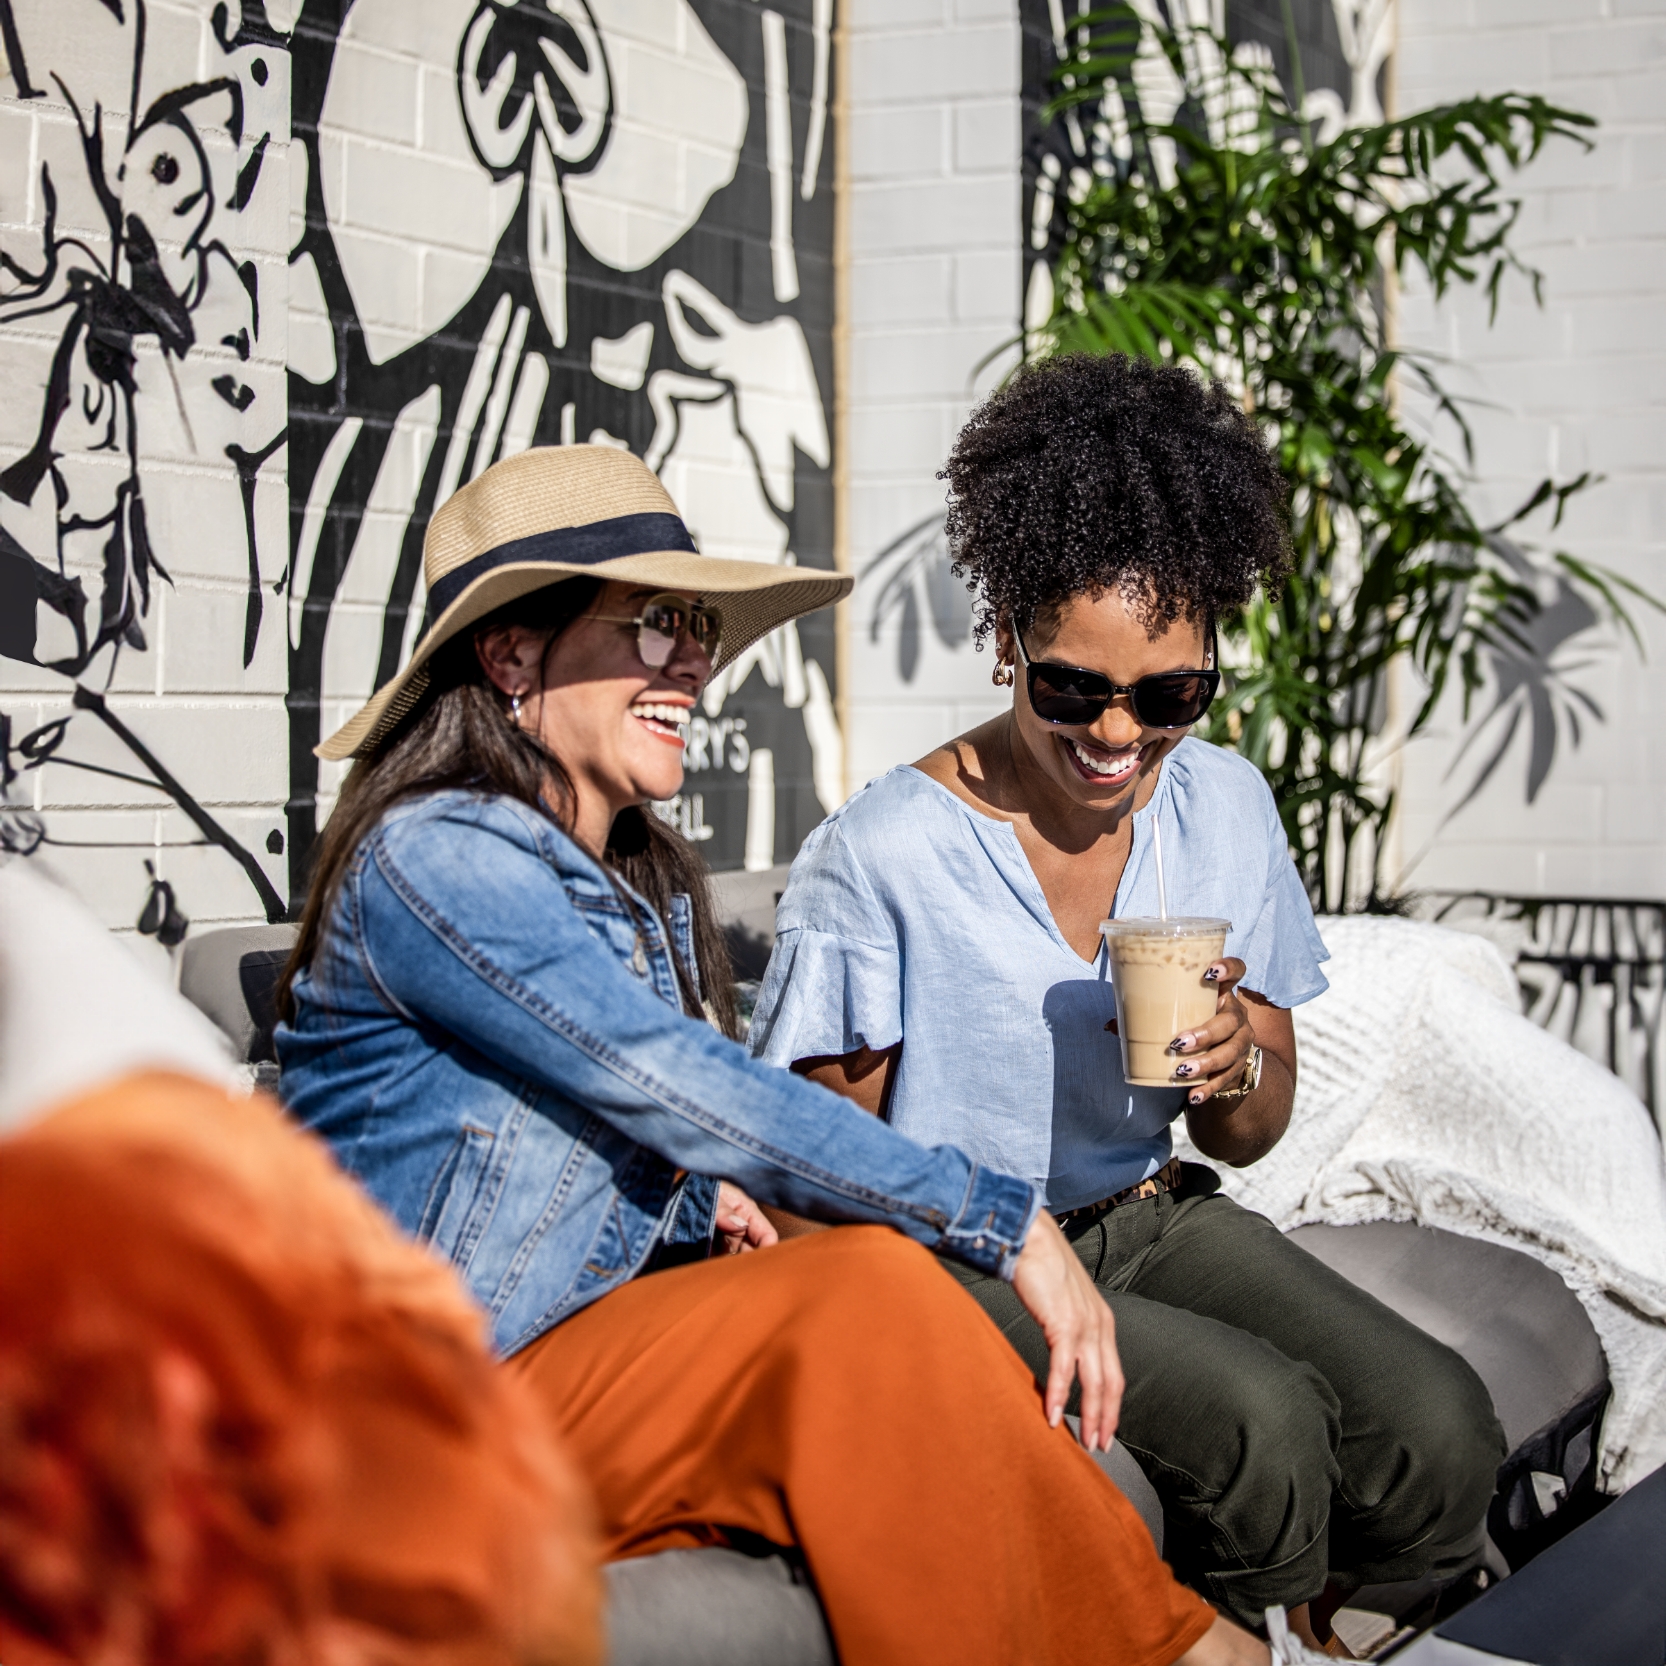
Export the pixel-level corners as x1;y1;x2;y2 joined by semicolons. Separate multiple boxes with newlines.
180;919;1608;1666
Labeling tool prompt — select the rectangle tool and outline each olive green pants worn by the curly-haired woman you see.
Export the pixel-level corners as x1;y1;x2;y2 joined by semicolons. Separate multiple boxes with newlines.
943;1163;1504;1626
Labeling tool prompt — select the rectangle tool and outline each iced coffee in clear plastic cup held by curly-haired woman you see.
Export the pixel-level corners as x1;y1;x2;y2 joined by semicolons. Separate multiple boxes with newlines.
1100;920;1231;1088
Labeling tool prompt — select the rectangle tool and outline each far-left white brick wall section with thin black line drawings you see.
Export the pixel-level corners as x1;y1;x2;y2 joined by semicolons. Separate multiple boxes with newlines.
0;0;288;930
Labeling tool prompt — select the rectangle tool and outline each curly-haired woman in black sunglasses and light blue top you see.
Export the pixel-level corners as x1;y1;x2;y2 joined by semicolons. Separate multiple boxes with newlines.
751;357;1503;1639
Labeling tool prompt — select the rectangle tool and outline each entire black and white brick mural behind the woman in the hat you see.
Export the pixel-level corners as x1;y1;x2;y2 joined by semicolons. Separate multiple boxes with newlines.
0;0;843;939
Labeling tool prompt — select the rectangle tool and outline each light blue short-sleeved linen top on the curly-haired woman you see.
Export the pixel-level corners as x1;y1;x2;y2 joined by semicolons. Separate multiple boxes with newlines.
750;736;1328;1211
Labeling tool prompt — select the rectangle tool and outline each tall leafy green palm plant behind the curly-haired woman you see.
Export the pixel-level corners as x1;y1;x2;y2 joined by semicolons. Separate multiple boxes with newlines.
1026;0;1661;911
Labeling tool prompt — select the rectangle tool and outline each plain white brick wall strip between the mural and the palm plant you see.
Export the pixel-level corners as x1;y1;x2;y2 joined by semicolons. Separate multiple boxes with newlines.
841;0;1020;788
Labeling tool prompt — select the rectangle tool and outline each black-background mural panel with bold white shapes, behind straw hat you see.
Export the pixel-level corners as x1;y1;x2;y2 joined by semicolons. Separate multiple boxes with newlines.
283;0;843;893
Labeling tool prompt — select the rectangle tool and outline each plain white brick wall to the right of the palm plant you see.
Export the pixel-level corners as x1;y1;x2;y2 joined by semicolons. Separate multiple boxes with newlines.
1398;0;1666;896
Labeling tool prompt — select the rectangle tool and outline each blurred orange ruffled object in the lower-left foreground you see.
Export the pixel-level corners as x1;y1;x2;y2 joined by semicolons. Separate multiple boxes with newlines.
0;1075;601;1666
